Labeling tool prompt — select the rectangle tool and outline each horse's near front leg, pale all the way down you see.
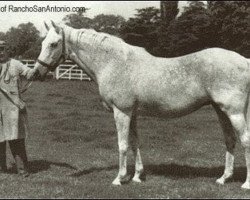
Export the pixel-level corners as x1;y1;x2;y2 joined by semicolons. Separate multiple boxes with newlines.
112;107;132;185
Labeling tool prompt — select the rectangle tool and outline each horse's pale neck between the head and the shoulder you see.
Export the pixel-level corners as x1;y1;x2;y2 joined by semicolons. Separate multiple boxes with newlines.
65;27;129;82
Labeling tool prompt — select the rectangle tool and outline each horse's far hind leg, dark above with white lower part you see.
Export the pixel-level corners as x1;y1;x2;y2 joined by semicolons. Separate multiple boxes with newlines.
214;105;236;184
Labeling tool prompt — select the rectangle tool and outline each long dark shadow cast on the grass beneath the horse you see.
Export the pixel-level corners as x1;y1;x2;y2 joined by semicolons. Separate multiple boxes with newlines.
70;163;246;182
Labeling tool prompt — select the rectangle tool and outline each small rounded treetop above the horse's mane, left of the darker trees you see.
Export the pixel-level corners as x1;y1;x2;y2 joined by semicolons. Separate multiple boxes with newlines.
91;14;126;35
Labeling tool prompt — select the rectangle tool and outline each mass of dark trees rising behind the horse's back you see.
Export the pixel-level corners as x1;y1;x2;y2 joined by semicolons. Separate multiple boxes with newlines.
121;1;250;57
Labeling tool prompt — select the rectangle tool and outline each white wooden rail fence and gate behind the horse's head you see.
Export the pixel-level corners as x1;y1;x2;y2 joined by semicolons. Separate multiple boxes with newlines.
22;60;91;81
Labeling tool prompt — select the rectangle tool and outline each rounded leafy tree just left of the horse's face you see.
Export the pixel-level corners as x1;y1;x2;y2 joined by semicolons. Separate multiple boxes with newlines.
5;22;39;57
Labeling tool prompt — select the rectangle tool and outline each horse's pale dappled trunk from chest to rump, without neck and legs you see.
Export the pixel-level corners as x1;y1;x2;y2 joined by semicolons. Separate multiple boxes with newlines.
99;47;250;117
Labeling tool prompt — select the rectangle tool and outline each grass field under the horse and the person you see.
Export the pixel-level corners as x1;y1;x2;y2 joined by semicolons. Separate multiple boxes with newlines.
0;80;250;198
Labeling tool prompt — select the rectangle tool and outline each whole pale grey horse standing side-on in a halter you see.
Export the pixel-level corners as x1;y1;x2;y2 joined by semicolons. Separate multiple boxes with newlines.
35;22;250;189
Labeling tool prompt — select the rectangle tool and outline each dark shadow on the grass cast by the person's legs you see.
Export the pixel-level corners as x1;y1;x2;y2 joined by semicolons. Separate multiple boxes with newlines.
28;160;77;174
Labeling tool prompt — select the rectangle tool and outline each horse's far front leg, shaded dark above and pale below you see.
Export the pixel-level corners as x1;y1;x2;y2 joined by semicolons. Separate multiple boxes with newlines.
129;111;143;183
